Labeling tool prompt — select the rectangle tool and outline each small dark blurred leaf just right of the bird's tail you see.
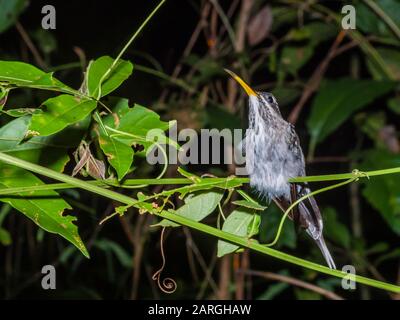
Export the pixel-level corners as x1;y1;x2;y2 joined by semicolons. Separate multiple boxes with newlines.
322;208;351;249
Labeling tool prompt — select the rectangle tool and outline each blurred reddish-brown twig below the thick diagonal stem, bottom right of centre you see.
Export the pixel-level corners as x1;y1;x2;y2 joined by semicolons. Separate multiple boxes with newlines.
237;270;344;300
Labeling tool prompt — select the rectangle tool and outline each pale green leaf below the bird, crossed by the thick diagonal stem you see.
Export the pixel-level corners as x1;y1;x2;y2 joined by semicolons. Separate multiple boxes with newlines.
217;208;254;257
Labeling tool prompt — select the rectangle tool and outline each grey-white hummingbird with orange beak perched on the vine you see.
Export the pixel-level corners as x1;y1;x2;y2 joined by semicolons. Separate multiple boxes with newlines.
225;69;336;269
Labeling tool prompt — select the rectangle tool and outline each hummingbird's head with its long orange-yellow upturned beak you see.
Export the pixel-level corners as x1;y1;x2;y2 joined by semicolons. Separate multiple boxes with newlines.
225;69;282;116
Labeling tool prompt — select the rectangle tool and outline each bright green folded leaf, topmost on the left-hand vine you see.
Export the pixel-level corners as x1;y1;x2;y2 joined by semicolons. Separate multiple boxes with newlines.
87;56;133;99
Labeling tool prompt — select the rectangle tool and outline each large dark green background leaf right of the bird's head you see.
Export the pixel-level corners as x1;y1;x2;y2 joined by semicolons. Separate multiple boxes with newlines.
307;78;395;150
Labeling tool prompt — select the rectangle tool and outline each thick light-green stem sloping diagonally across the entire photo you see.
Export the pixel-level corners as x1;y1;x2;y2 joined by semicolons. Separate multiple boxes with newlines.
0;152;400;293
